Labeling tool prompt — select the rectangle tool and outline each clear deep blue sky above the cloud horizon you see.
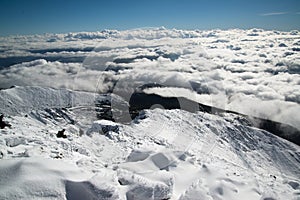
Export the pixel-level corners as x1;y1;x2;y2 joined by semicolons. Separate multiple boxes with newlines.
0;0;300;36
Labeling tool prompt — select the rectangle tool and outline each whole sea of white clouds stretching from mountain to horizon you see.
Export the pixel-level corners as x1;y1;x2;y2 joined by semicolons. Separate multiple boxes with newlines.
0;28;300;129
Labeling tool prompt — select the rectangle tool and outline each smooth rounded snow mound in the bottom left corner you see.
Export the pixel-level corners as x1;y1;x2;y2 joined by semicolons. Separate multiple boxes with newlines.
0;158;94;199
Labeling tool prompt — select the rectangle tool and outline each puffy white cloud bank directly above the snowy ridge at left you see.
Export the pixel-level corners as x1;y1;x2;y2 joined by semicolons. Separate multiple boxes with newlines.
0;59;115;92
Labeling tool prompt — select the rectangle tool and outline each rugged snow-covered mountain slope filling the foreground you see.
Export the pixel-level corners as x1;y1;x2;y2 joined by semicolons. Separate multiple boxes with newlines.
0;88;300;200
